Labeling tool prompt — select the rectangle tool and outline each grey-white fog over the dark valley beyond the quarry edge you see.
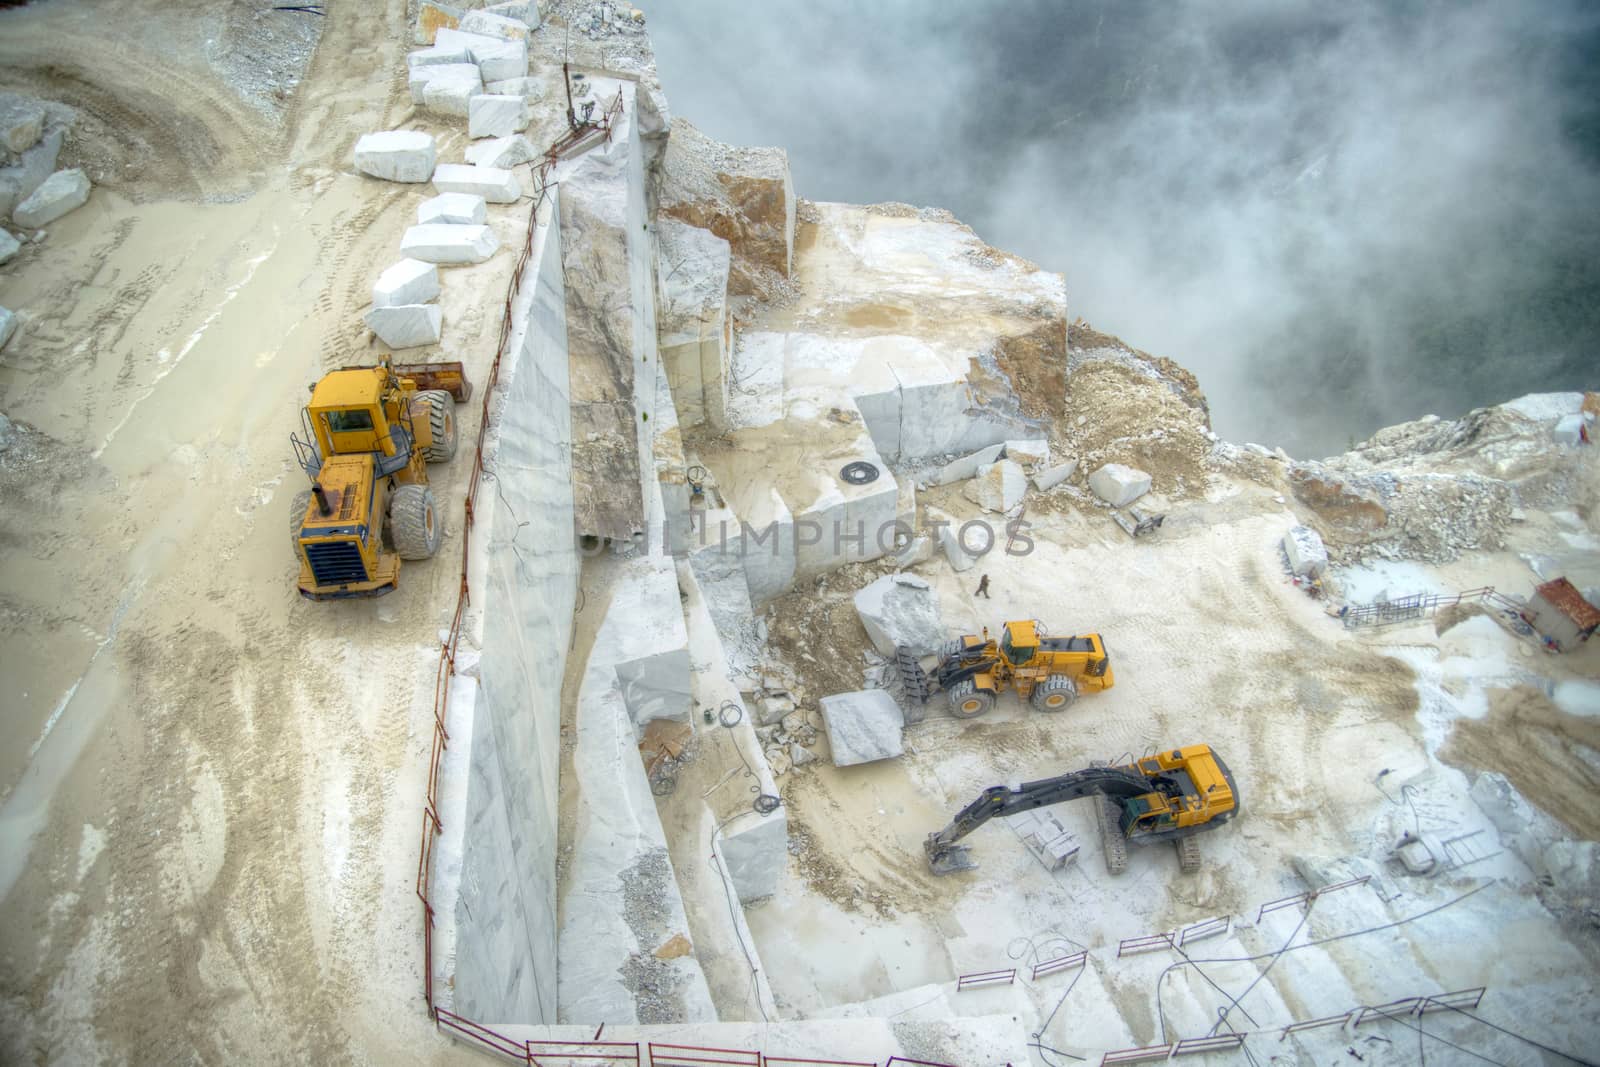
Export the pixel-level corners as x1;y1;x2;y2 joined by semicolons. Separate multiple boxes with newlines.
646;0;1600;454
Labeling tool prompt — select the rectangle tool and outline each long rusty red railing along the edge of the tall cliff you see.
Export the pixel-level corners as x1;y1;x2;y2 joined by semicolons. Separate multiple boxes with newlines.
416;90;637;1017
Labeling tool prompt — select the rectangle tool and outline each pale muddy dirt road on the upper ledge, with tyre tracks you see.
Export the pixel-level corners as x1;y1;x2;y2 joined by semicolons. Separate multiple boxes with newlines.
0;0;493;1064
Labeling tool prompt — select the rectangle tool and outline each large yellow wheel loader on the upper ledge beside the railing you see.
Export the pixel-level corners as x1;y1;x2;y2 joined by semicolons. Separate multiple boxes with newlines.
290;363;470;600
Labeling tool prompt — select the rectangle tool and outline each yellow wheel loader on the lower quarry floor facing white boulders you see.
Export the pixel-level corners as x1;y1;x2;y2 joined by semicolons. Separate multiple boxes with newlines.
894;619;1115;718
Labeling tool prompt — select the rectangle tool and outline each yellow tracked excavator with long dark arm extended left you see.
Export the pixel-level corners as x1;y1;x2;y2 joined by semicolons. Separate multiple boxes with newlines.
923;745;1238;875
